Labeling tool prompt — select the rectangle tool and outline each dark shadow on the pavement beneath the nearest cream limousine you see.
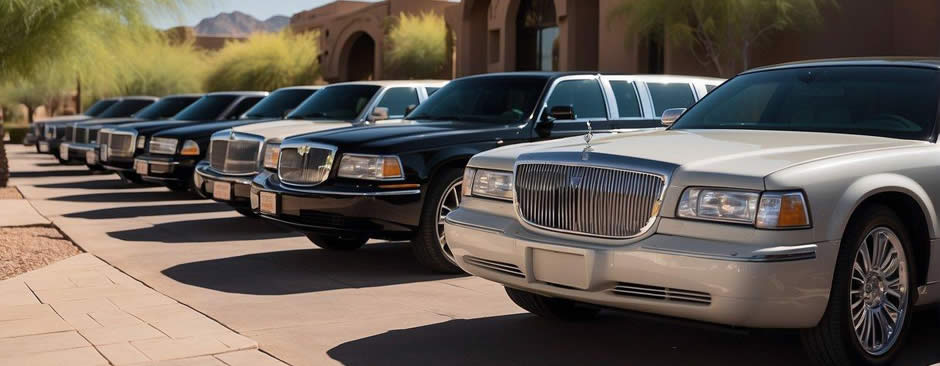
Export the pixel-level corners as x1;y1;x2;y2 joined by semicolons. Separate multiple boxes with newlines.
327;311;940;366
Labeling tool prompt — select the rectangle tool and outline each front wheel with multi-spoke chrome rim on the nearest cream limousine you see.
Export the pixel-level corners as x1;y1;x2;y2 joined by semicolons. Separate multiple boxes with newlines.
802;206;914;366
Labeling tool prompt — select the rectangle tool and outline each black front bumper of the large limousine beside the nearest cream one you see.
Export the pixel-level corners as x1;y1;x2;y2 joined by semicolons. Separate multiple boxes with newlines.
250;171;422;240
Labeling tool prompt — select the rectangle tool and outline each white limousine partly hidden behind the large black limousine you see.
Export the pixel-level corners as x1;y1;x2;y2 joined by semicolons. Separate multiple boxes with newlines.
196;80;446;216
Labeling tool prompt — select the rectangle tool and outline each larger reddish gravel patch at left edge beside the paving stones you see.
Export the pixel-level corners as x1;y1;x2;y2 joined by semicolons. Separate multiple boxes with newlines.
0;226;81;280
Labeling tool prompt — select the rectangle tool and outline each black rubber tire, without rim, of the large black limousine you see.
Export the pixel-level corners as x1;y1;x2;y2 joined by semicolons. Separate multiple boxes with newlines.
411;169;463;274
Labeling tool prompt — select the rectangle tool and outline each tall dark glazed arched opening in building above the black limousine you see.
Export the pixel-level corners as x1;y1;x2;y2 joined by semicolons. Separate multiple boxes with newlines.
516;0;559;71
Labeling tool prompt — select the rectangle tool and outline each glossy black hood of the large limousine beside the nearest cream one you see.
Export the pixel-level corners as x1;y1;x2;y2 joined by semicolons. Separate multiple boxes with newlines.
287;121;527;154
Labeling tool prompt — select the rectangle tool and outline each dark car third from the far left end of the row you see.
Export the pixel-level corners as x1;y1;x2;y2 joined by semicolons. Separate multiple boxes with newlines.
59;94;202;170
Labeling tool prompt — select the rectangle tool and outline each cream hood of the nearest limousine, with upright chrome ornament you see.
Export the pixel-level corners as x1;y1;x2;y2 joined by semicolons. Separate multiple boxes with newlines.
478;130;929;189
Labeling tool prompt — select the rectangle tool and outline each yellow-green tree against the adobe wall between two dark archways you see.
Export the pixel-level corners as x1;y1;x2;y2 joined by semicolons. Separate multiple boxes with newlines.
385;12;449;78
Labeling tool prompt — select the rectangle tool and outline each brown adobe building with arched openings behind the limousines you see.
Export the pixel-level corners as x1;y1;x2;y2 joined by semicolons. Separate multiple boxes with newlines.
291;0;940;81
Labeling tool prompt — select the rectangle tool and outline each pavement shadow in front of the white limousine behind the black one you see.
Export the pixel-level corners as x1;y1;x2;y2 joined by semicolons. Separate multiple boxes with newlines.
108;217;300;244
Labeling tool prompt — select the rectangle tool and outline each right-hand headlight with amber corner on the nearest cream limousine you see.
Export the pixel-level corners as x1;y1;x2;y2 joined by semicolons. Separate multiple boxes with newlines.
676;188;809;229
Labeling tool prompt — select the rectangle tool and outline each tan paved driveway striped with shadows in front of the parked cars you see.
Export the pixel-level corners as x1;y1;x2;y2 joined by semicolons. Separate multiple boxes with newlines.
9;147;940;365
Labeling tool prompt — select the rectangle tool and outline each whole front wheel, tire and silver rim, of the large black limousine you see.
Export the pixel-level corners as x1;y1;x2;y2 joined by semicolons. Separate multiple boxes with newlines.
411;169;463;273
